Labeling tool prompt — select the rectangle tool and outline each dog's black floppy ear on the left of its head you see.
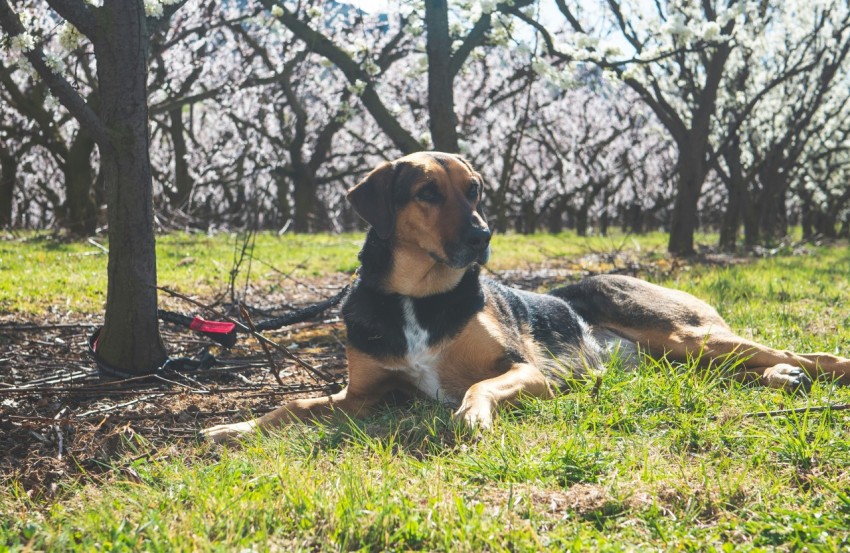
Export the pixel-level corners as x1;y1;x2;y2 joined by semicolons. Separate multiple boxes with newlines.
346;161;395;240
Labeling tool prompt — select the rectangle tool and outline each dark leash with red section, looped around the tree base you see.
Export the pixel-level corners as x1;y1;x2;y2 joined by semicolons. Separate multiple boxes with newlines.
88;285;351;378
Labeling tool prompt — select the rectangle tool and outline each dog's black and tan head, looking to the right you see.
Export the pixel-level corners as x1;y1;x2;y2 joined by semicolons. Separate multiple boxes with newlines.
348;152;490;268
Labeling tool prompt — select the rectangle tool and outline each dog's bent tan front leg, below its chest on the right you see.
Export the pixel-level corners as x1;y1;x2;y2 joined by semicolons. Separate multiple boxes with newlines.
455;363;552;429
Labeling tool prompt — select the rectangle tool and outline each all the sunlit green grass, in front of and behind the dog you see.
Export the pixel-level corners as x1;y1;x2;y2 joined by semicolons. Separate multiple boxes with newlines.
0;230;850;551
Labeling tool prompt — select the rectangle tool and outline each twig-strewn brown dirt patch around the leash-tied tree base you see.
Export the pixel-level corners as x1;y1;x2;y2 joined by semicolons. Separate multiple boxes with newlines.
0;275;356;499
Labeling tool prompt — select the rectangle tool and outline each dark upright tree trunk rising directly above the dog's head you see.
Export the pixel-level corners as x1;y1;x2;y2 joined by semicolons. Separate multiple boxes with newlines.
425;0;458;153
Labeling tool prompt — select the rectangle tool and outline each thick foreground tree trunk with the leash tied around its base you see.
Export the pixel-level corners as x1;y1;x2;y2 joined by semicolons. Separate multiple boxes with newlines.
93;0;166;374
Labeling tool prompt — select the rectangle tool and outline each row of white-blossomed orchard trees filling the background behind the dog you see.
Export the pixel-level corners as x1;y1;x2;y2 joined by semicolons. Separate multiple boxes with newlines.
0;0;850;254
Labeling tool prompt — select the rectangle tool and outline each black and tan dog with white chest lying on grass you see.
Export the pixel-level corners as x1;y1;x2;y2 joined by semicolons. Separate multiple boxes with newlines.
203;152;850;441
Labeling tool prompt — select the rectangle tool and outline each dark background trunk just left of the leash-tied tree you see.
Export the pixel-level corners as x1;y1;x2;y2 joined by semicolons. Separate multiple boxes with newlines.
62;129;97;236
